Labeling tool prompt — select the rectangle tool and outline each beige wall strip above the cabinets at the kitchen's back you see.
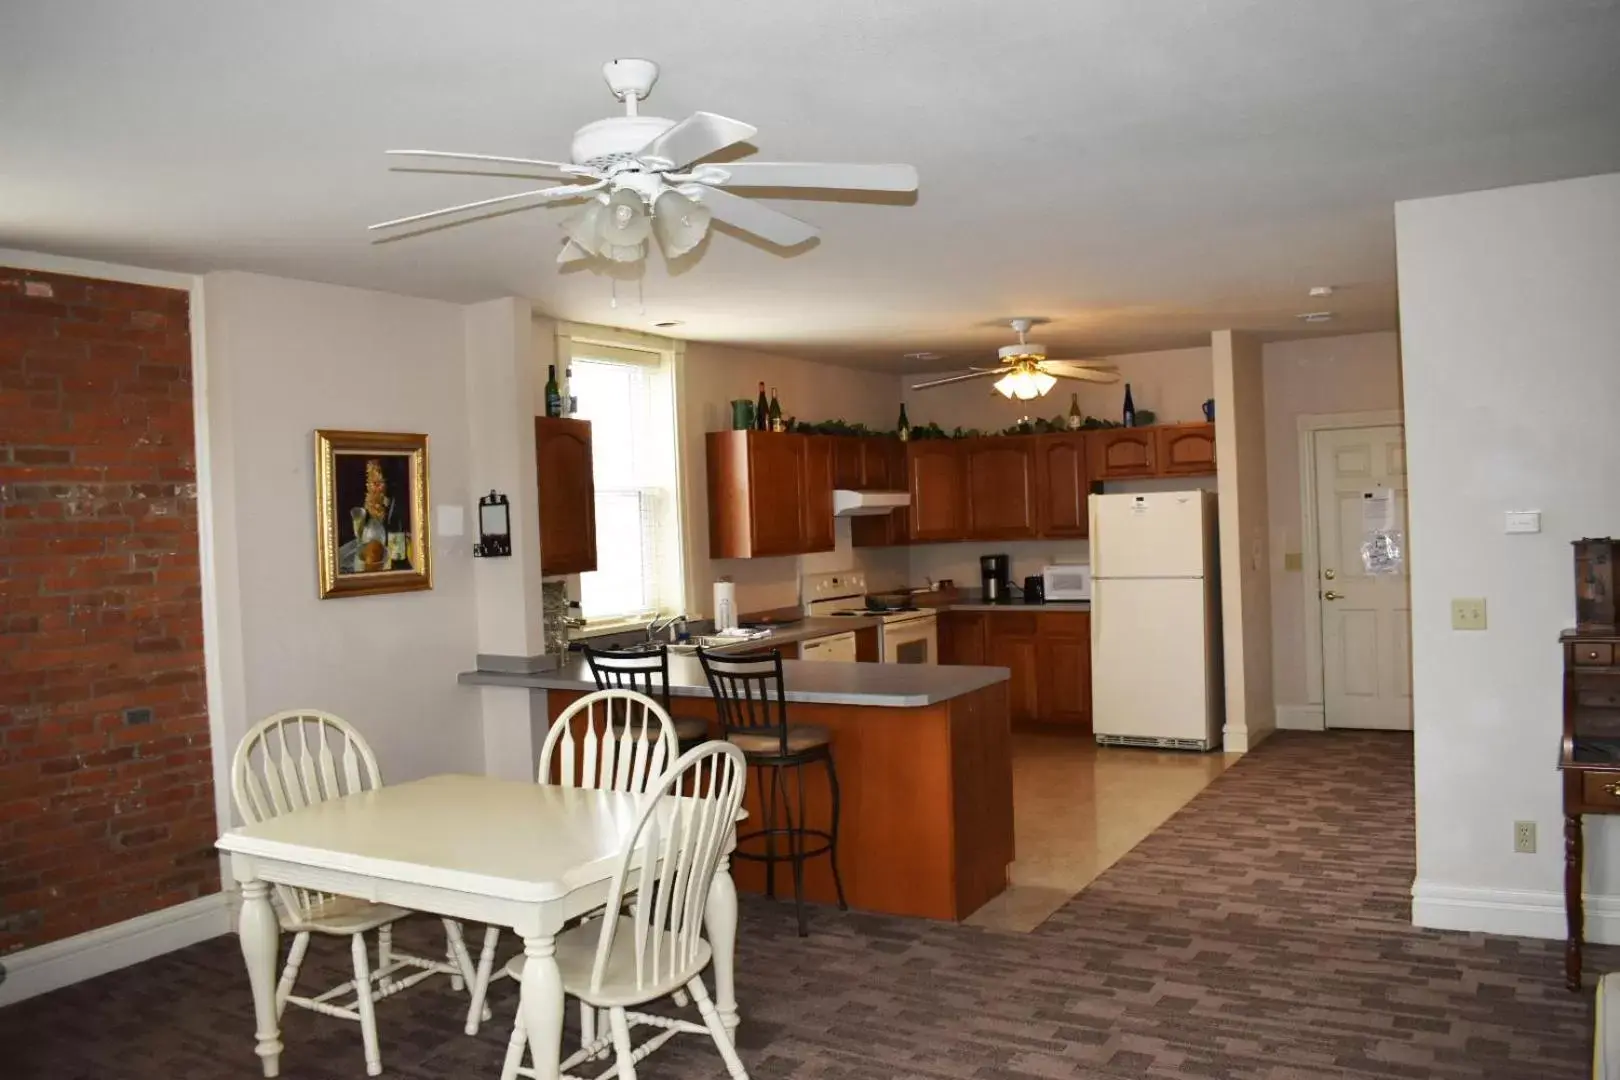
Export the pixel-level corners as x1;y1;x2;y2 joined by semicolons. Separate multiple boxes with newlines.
907;348;1213;431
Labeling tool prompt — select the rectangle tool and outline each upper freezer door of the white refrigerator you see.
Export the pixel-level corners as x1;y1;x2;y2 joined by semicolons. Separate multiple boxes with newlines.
1090;491;1207;578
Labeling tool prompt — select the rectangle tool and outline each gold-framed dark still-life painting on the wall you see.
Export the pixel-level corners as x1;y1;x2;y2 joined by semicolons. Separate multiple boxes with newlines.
314;431;433;599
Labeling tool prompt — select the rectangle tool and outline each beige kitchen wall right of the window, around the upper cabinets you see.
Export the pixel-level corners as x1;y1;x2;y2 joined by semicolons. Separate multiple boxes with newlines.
680;342;907;614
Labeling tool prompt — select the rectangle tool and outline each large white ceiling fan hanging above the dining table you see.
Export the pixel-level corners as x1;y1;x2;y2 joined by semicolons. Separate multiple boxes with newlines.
371;60;917;262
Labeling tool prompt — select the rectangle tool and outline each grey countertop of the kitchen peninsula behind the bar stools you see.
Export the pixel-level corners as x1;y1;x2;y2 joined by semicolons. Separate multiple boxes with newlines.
457;650;1008;709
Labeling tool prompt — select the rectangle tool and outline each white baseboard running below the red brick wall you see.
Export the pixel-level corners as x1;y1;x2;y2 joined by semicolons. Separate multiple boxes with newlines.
0;892;233;1006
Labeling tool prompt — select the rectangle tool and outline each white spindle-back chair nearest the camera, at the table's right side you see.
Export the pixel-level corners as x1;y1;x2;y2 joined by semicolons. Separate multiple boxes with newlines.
501;742;748;1080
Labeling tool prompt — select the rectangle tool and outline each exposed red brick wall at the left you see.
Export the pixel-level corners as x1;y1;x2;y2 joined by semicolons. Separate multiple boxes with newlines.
0;267;220;954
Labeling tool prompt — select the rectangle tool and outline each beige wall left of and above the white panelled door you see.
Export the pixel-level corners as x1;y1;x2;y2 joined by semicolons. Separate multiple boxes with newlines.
1262;332;1401;706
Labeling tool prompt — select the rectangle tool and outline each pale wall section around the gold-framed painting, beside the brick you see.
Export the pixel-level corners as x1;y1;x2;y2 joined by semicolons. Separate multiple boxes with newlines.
203;274;483;782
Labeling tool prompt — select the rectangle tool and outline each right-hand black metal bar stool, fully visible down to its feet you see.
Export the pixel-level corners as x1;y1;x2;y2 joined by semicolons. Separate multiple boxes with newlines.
698;649;849;938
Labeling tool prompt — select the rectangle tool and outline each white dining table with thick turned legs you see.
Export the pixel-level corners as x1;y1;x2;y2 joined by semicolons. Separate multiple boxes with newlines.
219;776;739;1080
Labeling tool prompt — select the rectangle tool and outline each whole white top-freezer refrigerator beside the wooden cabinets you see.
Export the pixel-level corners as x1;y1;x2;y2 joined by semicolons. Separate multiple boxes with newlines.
1090;491;1225;750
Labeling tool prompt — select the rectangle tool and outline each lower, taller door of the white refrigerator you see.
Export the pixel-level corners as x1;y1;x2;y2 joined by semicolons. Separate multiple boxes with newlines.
1092;578;1212;740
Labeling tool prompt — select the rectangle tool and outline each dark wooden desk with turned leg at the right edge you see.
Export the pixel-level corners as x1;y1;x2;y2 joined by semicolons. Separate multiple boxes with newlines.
1558;628;1620;989
